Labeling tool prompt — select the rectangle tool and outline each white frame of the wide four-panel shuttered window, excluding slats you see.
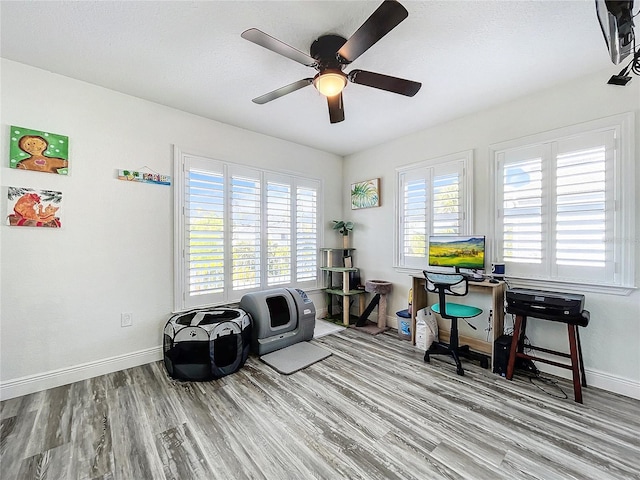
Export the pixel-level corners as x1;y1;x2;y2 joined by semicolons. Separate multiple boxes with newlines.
173;146;323;312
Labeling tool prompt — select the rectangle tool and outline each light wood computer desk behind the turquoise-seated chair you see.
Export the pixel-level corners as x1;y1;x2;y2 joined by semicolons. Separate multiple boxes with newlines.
411;275;506;370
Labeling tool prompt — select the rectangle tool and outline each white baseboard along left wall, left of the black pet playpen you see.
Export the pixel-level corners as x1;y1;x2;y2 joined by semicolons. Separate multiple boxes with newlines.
0;346;162;400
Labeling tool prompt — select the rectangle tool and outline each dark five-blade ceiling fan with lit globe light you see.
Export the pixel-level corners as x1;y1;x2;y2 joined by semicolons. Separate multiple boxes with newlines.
241;0;422;123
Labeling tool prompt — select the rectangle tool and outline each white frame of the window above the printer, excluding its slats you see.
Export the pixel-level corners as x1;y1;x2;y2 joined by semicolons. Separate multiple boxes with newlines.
489;112;636;295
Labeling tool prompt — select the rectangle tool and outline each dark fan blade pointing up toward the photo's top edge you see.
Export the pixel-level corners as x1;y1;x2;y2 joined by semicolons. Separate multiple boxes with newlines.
338;0;409;63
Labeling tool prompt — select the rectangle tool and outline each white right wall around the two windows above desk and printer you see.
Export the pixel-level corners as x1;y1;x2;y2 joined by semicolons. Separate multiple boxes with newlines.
343;71;640;398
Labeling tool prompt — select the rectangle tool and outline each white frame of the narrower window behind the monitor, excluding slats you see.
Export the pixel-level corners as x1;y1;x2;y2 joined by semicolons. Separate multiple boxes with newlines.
393;149;477;274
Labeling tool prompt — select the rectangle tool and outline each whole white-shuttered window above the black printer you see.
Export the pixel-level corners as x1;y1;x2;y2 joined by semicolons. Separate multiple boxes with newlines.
492;115;634;287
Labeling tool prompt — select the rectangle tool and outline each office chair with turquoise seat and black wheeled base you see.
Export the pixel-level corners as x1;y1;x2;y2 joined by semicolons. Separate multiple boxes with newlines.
423;270;489;375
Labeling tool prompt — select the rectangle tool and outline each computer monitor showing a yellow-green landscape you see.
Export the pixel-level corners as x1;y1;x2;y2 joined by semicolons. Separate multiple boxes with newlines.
429;235;485;272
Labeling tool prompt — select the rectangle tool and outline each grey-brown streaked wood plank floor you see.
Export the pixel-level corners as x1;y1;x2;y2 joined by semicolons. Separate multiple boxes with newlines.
0;329;640;480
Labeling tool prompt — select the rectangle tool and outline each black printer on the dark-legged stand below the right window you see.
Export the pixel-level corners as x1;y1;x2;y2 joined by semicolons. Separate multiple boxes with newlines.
506;288;584;320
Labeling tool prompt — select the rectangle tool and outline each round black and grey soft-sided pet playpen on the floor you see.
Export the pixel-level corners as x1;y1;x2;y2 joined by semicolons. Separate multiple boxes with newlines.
163;308;251;380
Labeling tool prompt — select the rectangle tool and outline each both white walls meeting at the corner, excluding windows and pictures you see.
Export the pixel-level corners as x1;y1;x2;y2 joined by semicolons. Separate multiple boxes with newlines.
0;60;640;399
